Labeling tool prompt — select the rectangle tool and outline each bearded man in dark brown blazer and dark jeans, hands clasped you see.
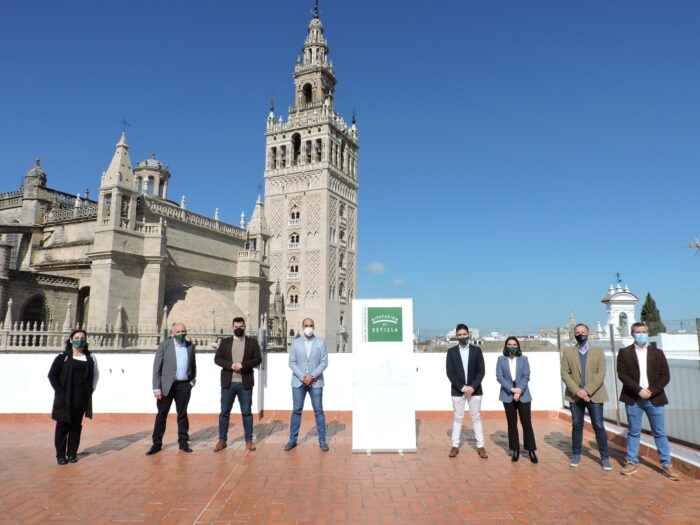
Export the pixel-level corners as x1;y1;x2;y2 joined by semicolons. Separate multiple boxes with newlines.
214;317;262;452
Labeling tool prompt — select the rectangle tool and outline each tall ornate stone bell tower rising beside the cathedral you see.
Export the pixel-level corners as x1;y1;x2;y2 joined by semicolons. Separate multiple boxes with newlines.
265;1;358;352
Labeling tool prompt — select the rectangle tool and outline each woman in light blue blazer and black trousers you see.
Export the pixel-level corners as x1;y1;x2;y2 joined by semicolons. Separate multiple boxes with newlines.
496;337;538;463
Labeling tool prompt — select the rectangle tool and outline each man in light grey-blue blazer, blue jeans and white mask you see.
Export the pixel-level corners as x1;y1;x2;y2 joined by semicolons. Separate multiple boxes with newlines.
284;318;328;452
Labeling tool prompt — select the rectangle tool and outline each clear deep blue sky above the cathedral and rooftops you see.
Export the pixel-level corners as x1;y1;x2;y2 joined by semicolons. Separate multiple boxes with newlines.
0;0;700;332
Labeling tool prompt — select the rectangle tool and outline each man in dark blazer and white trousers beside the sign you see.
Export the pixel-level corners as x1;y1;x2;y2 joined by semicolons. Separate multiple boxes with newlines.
447;323;489;459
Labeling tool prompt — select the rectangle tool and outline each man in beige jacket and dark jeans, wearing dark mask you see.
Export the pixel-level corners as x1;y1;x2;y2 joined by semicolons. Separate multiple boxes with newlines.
561;324;612;470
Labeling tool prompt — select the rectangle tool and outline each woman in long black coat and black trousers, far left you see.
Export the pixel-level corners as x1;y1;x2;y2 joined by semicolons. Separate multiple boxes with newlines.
49;330;99;465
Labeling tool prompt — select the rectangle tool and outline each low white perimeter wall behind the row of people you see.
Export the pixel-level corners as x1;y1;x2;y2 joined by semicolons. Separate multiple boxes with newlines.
0;352;562;414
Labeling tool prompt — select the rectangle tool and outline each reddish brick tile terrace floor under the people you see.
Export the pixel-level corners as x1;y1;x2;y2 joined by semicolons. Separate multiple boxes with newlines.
0;412;700;525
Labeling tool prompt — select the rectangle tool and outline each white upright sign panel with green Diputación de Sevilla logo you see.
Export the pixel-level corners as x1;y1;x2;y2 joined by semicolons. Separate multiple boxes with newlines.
352;299;416;452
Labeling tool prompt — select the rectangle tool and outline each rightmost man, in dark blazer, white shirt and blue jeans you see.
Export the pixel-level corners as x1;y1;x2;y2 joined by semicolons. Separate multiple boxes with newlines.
617;323;679;481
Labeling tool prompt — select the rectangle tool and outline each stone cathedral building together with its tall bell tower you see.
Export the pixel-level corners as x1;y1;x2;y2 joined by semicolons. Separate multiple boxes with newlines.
0;4;358;352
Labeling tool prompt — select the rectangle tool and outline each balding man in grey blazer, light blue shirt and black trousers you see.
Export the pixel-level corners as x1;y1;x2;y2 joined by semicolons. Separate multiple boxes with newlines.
146;323;197;456
